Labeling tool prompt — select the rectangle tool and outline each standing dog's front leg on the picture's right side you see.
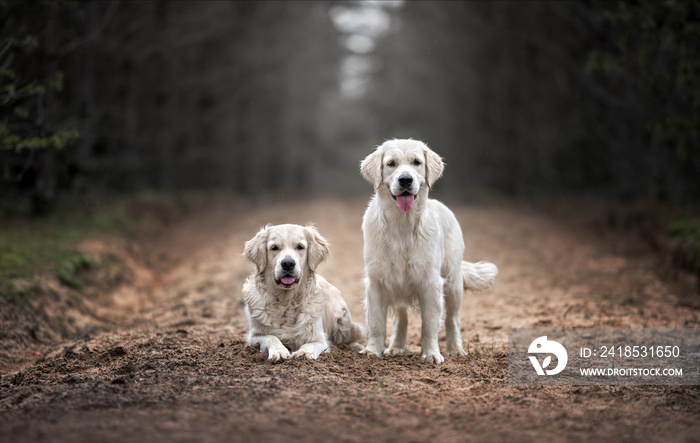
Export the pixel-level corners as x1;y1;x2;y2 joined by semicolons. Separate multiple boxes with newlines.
420;273;445;364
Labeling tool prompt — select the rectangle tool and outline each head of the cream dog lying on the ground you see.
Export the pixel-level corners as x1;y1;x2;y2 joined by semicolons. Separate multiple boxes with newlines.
243;225;328;290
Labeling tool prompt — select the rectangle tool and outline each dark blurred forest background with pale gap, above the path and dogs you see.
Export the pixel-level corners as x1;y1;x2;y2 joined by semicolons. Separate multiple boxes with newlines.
0;0;700;214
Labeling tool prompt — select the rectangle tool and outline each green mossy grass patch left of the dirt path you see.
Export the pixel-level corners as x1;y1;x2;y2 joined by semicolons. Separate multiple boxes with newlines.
0;194;190;300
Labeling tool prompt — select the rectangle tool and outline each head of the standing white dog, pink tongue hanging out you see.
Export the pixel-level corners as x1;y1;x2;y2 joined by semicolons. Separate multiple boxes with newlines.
360;139;445;211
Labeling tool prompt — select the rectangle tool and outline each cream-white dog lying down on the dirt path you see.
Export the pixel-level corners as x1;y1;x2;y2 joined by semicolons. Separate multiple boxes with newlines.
243;225;364;361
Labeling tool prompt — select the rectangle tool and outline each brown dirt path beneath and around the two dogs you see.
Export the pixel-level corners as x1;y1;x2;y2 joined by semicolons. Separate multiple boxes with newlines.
0;200;700;442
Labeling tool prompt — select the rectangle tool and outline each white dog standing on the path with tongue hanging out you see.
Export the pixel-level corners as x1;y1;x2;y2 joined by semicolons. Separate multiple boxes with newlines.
360;139;498;363
